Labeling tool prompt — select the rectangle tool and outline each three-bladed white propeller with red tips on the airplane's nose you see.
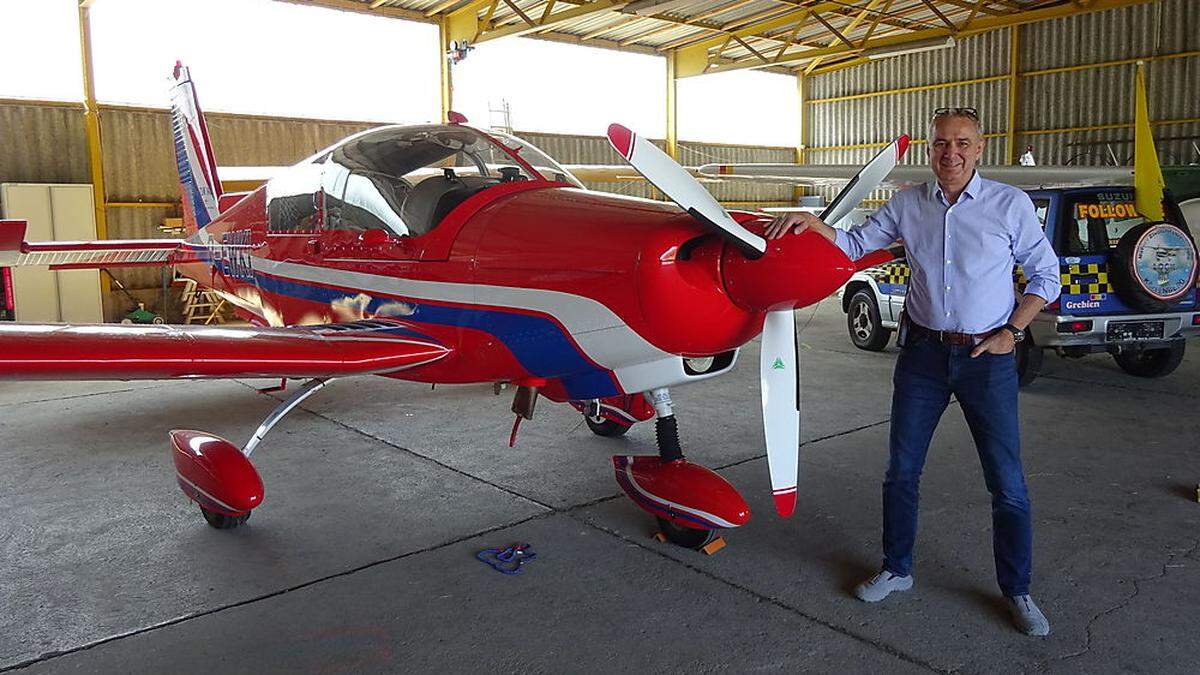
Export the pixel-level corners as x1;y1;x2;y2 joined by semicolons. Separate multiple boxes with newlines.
608;124;908;516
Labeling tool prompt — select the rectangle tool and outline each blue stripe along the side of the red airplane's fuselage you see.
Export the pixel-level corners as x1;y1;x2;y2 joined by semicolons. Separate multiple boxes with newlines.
254;267;620;400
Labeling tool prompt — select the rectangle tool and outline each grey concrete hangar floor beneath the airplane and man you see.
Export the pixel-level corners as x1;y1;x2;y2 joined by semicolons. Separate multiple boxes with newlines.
0;300;1200;673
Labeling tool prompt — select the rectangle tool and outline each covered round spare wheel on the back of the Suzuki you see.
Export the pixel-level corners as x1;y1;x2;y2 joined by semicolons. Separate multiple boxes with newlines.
1110;222;1196;312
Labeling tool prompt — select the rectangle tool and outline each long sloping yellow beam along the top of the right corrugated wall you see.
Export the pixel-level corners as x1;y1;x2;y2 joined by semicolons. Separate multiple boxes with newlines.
707;0;1154;72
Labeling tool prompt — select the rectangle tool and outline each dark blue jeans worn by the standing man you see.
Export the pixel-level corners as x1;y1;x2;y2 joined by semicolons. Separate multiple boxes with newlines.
883;331;1033;597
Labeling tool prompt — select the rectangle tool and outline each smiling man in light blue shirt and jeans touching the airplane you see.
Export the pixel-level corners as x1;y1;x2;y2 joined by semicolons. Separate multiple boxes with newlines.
767;108;1060;635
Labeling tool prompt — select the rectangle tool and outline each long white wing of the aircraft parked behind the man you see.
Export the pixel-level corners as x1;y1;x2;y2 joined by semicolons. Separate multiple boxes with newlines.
700;163;1133;189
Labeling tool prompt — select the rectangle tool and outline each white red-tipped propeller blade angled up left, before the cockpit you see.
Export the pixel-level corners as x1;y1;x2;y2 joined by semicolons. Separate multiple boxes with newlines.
608;124;767;258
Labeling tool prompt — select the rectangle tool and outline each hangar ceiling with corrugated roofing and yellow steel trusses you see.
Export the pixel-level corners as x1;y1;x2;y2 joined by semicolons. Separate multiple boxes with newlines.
289;0;1151;77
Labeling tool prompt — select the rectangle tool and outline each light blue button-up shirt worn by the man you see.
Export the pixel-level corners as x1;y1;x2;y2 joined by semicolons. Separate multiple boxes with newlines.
834;172;1062;333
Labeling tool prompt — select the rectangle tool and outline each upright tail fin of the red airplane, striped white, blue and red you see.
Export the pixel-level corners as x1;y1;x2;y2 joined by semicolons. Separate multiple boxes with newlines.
170;61;221;234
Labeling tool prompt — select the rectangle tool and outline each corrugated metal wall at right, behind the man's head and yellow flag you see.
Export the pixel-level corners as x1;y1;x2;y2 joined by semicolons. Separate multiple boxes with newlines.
808;0;1200;176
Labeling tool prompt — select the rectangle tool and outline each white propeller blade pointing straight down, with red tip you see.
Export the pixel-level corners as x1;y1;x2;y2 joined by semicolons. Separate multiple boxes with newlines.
758;309;800;518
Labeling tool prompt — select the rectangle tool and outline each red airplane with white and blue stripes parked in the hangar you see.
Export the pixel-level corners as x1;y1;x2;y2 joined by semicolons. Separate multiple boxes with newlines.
0;64;907;546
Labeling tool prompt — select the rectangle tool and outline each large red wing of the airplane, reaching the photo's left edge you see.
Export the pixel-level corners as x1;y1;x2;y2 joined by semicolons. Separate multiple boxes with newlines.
0;321;450;380
